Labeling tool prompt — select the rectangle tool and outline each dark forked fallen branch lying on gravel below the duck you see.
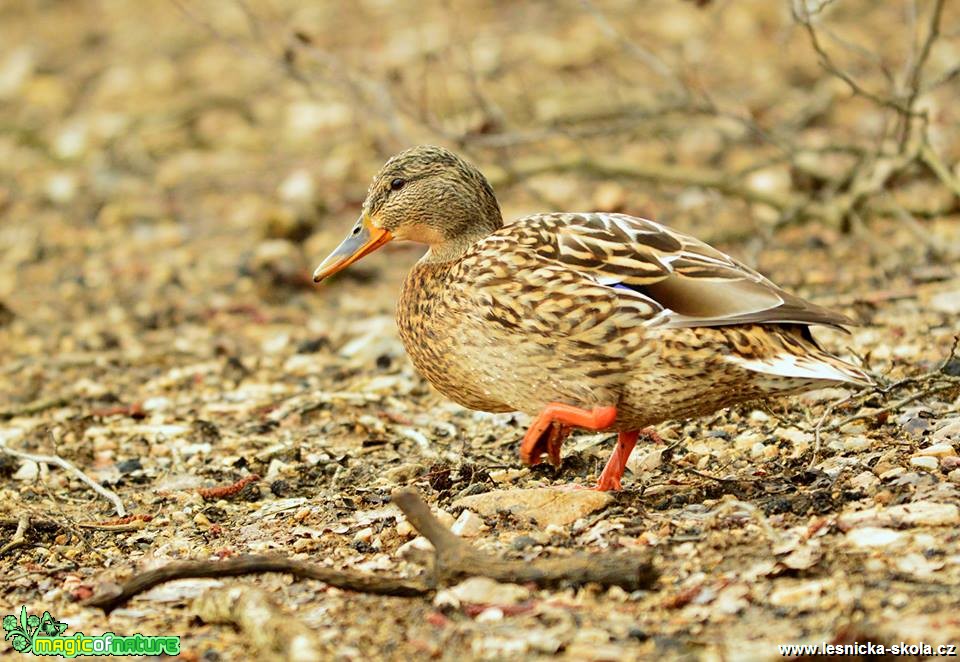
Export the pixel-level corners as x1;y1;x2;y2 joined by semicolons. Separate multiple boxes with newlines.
86;489;656;613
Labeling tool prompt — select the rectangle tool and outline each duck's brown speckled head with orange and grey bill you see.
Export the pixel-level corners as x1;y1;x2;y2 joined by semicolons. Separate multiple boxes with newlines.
313;145;503;283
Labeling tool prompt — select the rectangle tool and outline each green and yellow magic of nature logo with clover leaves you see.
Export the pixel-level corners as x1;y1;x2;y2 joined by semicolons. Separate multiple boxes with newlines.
3;606;180;657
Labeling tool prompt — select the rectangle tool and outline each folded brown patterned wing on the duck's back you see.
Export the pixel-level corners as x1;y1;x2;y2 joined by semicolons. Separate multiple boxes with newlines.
504;213;853;329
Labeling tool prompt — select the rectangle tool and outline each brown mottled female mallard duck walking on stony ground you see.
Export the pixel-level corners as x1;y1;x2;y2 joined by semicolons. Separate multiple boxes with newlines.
314;146;871;490
